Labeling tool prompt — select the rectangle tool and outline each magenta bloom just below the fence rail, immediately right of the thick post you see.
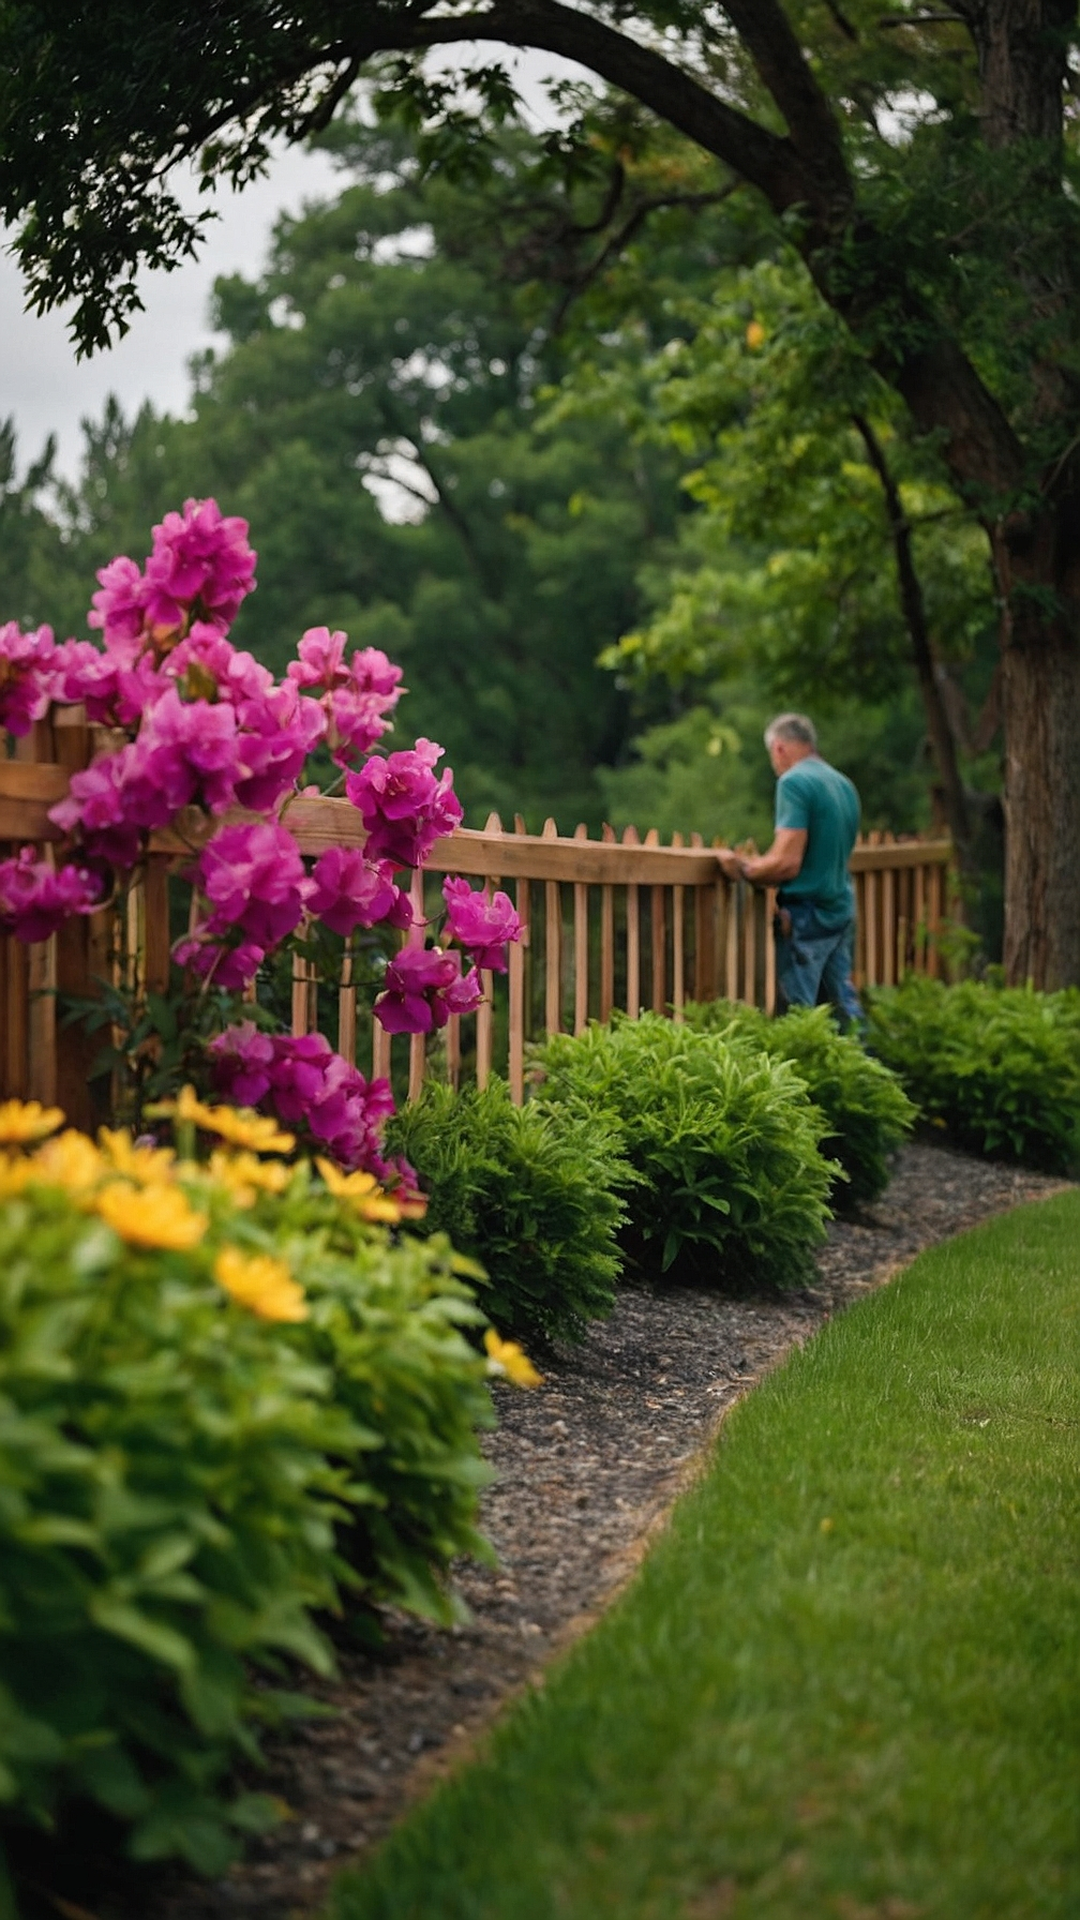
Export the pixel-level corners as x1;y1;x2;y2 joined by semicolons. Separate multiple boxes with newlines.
196;820;311;952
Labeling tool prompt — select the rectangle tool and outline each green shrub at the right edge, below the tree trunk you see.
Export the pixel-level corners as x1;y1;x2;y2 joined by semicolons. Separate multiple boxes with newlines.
869;975;1080;1173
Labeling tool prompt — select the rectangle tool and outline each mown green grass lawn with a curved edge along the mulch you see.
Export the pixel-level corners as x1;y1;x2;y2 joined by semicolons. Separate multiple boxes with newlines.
331;1194;1080;1920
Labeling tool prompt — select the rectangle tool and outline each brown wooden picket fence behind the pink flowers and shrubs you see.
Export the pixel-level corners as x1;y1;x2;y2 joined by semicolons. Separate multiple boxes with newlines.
0;707;951;1125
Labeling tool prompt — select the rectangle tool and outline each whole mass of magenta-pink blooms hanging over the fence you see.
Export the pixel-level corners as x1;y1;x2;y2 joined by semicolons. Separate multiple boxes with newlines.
0;499;521;1182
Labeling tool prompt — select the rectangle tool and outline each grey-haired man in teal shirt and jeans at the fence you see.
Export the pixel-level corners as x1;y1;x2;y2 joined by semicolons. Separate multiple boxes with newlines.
717;714;863;1027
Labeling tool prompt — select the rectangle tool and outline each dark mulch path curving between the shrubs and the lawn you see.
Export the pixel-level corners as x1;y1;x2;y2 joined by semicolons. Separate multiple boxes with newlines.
44;1144;1061;1920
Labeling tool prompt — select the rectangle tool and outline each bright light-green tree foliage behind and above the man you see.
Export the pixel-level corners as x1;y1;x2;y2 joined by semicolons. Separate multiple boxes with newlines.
584;250;997;829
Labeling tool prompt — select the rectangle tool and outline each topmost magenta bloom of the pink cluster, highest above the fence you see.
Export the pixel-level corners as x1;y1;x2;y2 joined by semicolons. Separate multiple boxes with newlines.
144;499;256;634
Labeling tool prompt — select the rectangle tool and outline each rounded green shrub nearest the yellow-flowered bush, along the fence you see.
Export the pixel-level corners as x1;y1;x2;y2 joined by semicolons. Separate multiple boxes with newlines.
386;1081;632;1340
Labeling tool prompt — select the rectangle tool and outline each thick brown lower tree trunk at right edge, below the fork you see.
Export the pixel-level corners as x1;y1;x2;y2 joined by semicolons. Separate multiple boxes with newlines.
995;501;1080;989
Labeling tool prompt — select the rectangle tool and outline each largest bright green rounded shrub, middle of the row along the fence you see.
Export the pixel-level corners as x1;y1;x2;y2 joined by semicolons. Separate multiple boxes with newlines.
534;1014;832;1284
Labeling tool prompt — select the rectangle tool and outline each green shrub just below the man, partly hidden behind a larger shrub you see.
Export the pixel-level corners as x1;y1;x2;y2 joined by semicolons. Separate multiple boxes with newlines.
686;1000;917;1208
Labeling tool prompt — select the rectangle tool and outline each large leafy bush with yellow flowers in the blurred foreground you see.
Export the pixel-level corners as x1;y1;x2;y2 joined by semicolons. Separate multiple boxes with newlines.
0;1102;490;1872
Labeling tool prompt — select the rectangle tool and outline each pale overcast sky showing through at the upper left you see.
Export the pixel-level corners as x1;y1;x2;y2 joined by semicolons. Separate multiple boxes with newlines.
0;50;580;474
